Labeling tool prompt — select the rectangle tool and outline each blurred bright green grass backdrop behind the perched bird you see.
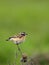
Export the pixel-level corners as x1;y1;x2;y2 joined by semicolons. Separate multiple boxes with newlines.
0;0;49;65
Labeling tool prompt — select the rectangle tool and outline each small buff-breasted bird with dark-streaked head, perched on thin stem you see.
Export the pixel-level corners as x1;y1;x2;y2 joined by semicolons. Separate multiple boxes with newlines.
6;32;28;45
